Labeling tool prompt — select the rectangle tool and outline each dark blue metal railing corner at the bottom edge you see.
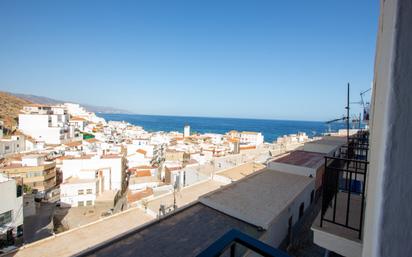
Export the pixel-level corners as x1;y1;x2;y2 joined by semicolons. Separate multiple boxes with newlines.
197;229;289;257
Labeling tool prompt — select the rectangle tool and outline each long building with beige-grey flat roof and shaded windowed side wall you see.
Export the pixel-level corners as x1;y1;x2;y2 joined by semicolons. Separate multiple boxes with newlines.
199;169;314;246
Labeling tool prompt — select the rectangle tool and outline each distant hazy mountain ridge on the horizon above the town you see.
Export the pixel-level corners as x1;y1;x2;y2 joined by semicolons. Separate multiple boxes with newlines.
9;93;133;114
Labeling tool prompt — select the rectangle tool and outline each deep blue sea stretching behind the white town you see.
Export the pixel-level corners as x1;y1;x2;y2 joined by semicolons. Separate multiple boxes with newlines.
97;113;352;143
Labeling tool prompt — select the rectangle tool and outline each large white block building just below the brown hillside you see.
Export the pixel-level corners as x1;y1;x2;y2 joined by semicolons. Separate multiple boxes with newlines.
19;105;80;144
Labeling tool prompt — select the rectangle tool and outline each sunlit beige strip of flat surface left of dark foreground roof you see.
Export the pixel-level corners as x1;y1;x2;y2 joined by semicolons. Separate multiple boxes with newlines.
5;208;152;257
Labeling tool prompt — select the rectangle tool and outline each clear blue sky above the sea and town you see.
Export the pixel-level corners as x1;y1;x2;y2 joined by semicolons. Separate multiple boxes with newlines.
0;0;379;120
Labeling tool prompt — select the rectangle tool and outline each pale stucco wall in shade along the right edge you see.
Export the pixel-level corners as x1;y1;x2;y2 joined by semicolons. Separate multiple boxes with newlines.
363;0;412;257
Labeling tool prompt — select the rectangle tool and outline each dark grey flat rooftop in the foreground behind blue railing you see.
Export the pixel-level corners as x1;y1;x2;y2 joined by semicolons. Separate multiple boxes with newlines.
79;203;263;257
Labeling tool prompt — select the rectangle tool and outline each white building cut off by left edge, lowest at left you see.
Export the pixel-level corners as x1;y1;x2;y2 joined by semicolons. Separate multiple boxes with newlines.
0;174;23;247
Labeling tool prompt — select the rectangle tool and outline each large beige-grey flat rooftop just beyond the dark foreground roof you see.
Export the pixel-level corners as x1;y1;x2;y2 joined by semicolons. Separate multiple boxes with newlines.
199;168;313;229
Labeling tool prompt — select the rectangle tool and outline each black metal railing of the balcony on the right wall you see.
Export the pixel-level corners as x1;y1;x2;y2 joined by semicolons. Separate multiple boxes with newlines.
320;131;368;239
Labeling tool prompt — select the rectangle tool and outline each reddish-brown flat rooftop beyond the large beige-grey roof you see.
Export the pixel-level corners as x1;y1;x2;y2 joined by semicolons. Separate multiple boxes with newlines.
274;150;325;169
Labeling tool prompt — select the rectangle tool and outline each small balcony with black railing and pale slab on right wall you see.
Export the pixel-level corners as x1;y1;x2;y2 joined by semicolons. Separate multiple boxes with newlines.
312;132;369;256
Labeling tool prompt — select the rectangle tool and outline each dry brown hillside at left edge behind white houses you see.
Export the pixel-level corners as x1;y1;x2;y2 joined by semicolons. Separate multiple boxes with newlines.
0;92;32;132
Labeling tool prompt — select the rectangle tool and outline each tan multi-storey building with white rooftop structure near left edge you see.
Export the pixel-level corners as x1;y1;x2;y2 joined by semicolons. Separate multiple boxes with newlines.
0;154;56;196
